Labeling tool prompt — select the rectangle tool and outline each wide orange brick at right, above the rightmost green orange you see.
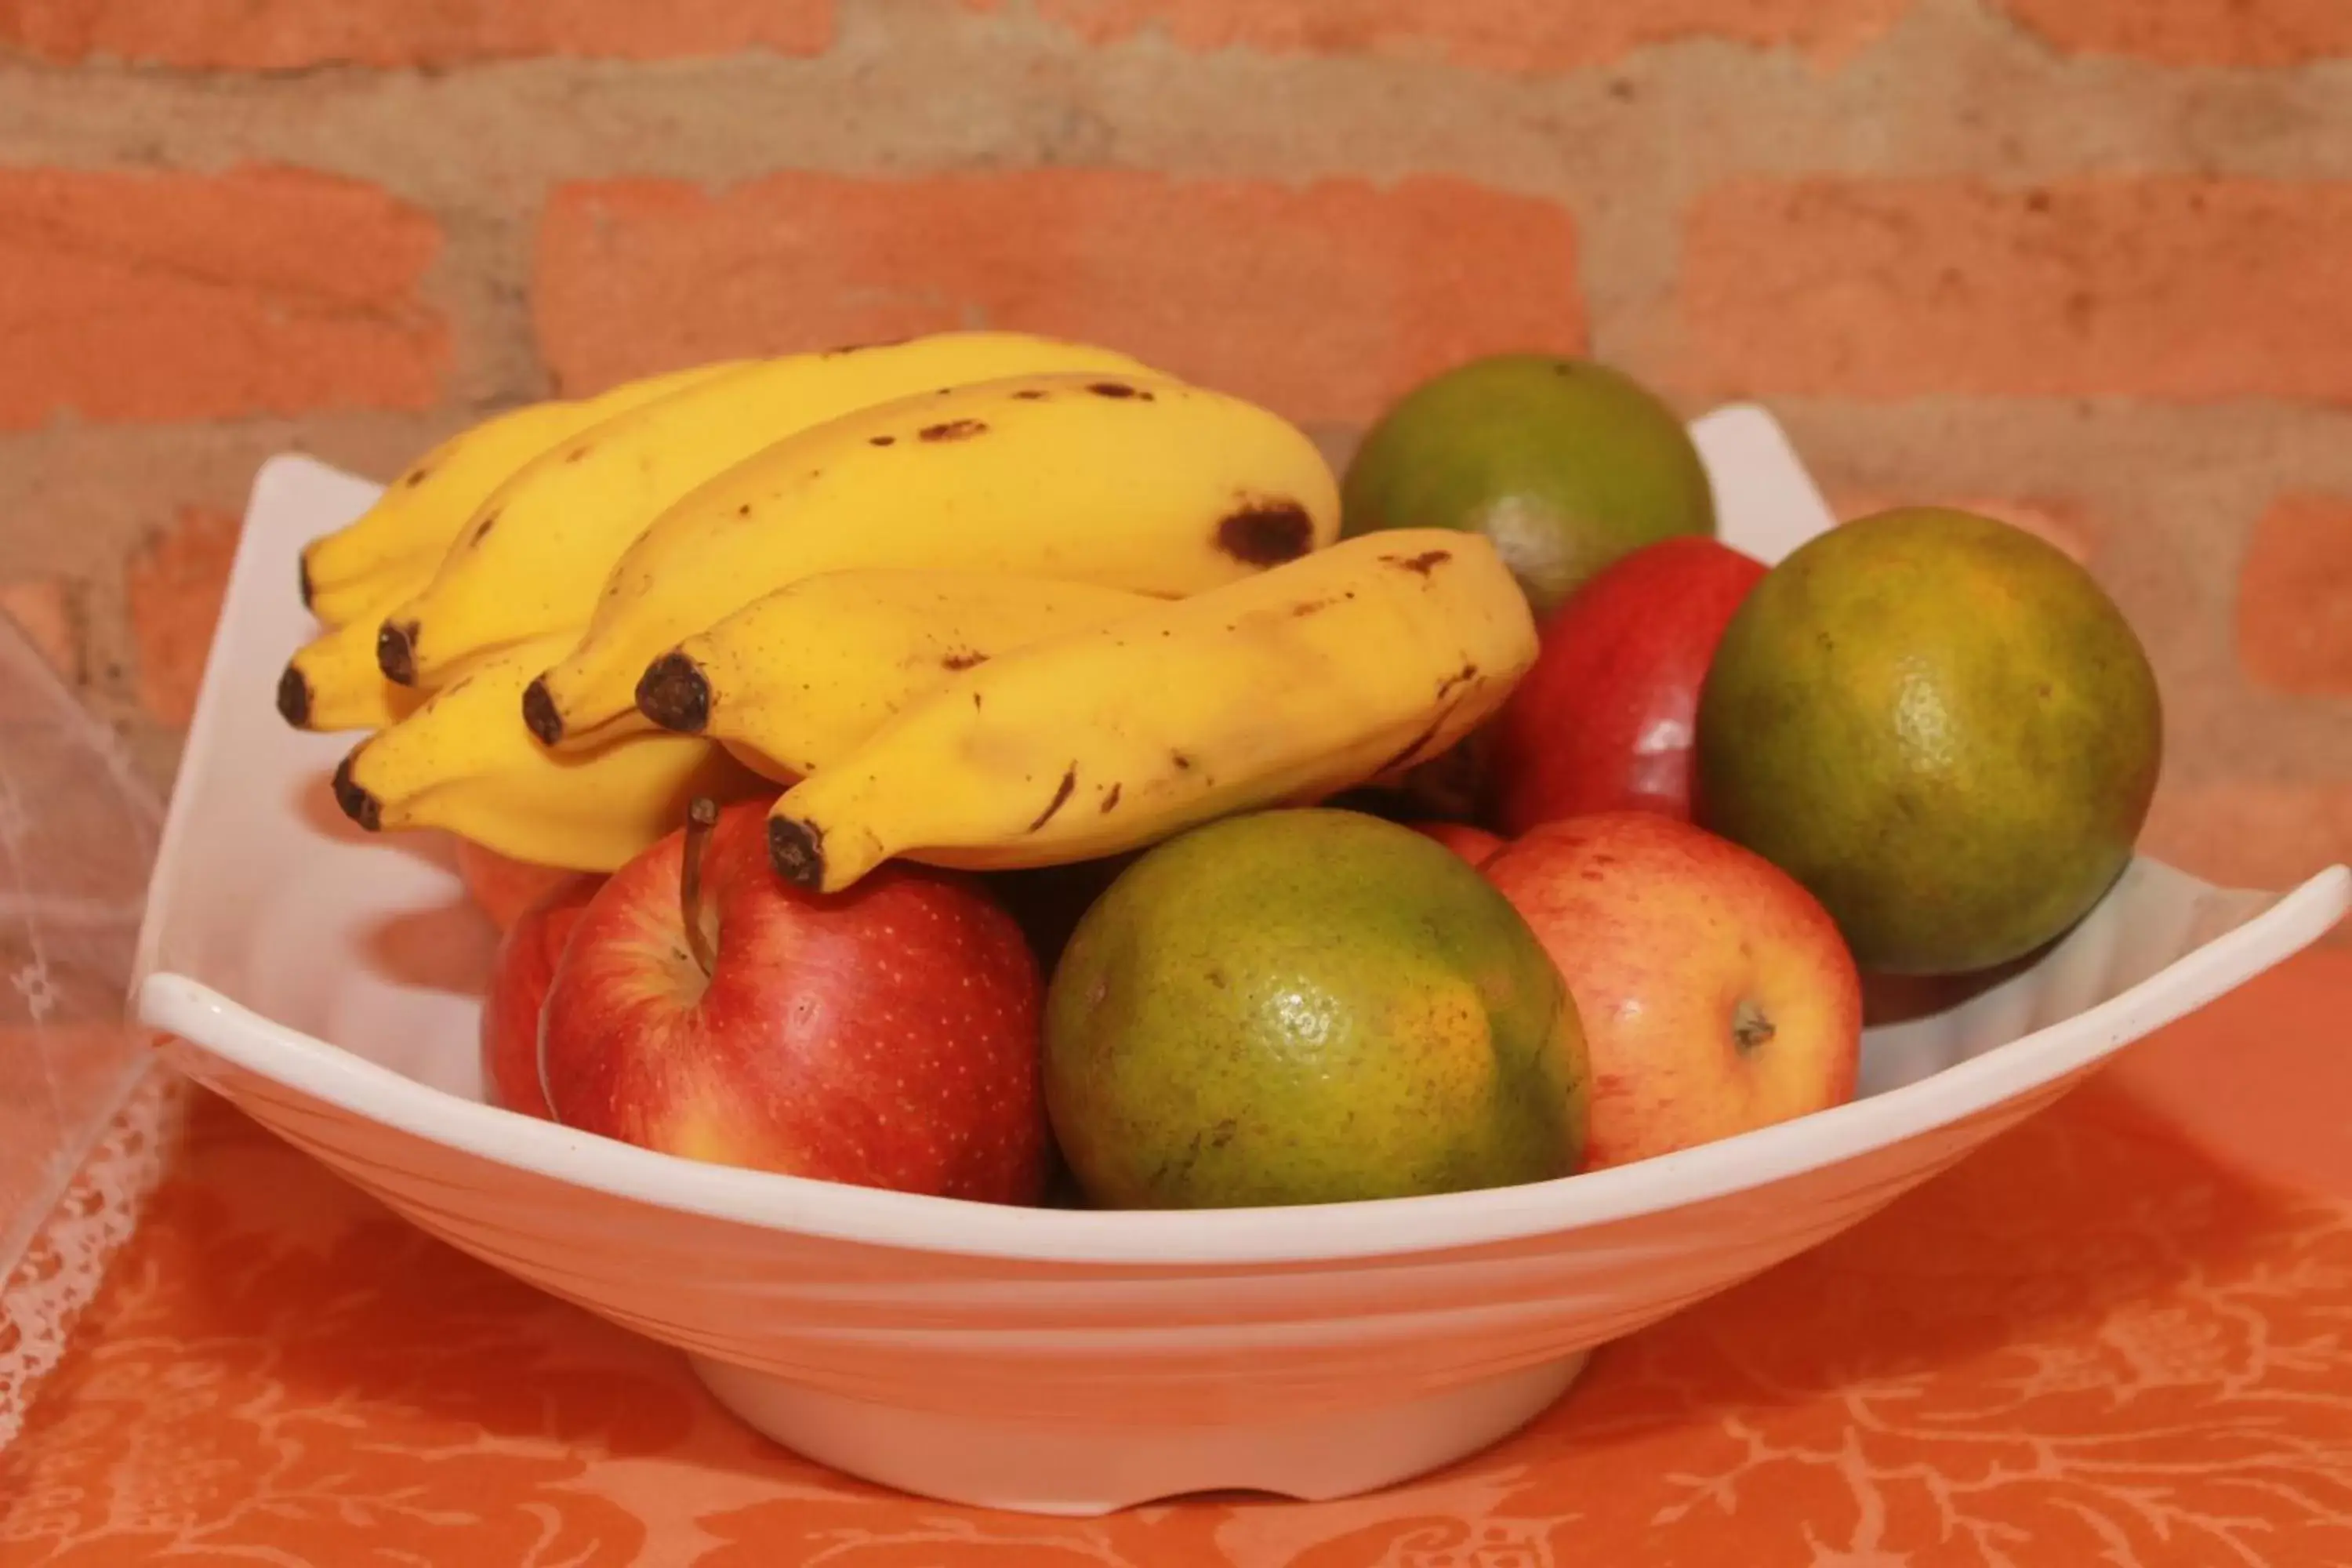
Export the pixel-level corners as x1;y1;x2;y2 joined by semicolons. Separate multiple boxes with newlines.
1679;176;2352;400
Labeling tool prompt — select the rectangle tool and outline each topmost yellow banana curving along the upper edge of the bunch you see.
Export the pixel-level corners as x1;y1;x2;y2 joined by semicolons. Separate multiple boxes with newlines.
381;332;1167;687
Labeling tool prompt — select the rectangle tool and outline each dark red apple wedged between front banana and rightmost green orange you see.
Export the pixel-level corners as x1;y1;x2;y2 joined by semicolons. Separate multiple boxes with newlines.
1489;536;1764;837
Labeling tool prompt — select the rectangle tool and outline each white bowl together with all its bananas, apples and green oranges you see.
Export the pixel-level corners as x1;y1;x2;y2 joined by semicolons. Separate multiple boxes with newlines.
141;332;2345;1509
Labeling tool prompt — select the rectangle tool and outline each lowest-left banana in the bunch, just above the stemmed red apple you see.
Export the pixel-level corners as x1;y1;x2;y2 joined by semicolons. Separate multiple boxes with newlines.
334;637;774;872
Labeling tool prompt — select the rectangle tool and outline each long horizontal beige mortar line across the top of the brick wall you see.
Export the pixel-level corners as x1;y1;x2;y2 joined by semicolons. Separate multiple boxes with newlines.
0;0;2352;205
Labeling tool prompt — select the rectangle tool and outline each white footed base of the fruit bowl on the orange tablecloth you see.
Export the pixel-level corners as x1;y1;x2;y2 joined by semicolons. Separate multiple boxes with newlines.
691;1354;1585;1516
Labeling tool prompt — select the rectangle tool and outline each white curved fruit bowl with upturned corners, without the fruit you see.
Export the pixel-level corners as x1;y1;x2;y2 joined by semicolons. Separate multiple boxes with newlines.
136;407;2352;1514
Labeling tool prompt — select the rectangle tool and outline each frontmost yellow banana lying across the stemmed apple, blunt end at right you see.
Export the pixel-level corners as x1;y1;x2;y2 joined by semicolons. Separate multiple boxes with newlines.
769;529;1536;891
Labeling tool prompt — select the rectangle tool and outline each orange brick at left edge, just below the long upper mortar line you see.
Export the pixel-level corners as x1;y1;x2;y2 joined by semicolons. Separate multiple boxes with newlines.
0;169;449;428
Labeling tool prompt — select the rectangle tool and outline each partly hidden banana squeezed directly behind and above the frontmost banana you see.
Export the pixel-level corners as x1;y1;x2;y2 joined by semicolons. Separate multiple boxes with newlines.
637;569;1162;781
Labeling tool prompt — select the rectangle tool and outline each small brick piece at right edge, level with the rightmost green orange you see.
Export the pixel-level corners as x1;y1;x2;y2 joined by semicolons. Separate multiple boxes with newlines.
2237;496;2352;696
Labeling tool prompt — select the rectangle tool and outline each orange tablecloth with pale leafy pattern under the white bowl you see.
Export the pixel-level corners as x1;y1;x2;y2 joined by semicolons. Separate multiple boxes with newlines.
0;949;2352;1568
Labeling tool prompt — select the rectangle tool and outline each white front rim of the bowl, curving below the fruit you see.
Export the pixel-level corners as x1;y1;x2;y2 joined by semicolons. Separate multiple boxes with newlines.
136;865;2352;1267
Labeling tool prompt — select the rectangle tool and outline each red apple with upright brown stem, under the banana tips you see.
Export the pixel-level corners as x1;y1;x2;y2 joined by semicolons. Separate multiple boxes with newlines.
539;801;1049;1203
